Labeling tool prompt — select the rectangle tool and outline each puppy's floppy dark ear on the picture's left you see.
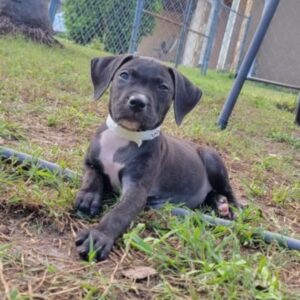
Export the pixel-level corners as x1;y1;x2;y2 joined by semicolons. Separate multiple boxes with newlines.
91;55;133;100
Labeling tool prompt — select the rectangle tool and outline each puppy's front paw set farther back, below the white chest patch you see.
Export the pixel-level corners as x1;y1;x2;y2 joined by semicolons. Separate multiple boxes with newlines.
75;190;101;217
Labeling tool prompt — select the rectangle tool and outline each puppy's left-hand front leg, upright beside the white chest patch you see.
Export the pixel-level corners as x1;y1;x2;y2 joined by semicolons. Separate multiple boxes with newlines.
75;162;103;216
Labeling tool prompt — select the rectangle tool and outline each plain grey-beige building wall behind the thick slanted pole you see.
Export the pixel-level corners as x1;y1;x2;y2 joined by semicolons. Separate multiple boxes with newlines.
246;0;300;86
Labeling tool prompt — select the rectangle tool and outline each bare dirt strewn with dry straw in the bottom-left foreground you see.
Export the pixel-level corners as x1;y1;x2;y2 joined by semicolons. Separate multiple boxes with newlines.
0;206;158;300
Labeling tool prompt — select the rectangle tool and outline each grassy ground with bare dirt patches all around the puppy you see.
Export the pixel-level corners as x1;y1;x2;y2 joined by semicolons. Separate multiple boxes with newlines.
0;38;300;300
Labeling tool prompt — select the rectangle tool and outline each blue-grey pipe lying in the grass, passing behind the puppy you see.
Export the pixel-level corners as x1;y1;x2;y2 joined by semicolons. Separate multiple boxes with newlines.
0;147;300;250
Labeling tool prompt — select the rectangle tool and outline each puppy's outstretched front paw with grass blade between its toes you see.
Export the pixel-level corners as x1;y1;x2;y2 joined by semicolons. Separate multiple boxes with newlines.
75;229;114;261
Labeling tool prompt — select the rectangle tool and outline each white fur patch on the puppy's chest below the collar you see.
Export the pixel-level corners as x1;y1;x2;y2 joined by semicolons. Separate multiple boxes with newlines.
99;129;129;189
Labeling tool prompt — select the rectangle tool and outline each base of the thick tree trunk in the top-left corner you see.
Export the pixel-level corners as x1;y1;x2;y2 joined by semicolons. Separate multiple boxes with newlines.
0;0;58;45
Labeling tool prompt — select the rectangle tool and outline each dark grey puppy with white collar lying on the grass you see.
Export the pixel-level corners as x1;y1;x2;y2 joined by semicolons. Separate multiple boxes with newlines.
75;55;239;260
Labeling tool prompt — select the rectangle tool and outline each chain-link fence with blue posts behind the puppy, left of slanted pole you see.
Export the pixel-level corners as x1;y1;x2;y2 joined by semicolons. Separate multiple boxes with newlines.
49;0;251;74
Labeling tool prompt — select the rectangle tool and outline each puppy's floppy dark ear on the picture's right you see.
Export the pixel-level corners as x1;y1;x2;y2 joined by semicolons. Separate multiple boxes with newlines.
169;68;202;125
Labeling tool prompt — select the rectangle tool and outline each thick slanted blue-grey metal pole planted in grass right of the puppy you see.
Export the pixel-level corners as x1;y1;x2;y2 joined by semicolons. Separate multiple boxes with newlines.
218;0;279;129
